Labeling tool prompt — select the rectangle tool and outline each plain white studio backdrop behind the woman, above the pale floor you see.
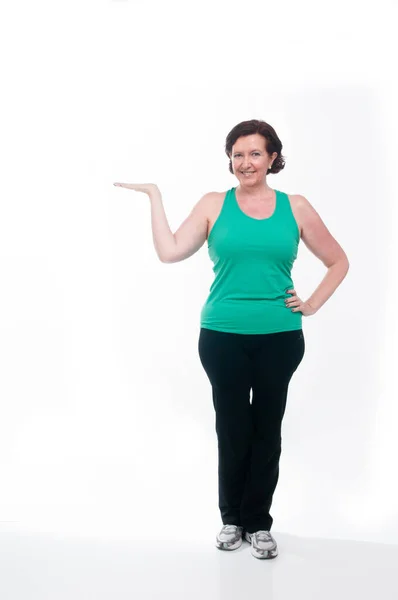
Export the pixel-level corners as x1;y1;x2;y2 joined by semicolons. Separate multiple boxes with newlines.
0;0;398;543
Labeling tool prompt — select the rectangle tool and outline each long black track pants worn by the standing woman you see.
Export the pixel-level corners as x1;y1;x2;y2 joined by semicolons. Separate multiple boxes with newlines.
198;328;305;533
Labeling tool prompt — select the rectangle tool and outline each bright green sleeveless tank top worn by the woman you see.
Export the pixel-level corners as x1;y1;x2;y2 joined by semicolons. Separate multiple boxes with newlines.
200;188;302;334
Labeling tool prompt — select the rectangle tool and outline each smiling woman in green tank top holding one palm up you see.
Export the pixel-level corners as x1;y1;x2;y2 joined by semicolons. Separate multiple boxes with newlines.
114;120;349;558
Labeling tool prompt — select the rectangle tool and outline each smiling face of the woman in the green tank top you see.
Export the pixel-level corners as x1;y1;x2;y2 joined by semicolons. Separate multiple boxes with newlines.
231;133;278;185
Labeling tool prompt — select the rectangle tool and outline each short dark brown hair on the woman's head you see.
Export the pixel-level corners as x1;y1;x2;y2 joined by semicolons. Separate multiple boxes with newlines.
225;119;285;174
